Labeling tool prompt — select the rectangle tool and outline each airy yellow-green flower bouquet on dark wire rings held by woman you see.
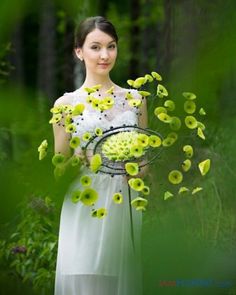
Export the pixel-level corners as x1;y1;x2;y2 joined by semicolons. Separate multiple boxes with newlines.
38;72;211;218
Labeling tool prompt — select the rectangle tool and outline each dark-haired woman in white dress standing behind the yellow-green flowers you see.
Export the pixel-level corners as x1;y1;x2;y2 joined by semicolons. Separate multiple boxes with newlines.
53;16;147;295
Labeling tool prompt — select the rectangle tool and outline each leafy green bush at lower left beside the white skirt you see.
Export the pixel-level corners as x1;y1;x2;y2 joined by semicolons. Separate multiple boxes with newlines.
0;197;57;294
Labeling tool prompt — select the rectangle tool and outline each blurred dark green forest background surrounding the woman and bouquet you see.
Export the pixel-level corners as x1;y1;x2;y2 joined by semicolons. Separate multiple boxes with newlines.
0;0;236;295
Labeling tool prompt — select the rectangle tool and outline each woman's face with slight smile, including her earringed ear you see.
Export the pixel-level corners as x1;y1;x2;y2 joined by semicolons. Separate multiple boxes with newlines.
76;29;117;75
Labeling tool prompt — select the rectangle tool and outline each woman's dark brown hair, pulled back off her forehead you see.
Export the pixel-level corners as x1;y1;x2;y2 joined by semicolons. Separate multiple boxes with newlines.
74;16;118;48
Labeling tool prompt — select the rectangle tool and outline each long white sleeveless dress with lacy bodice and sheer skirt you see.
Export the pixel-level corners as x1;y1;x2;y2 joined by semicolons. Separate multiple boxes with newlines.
55;89;142;295
